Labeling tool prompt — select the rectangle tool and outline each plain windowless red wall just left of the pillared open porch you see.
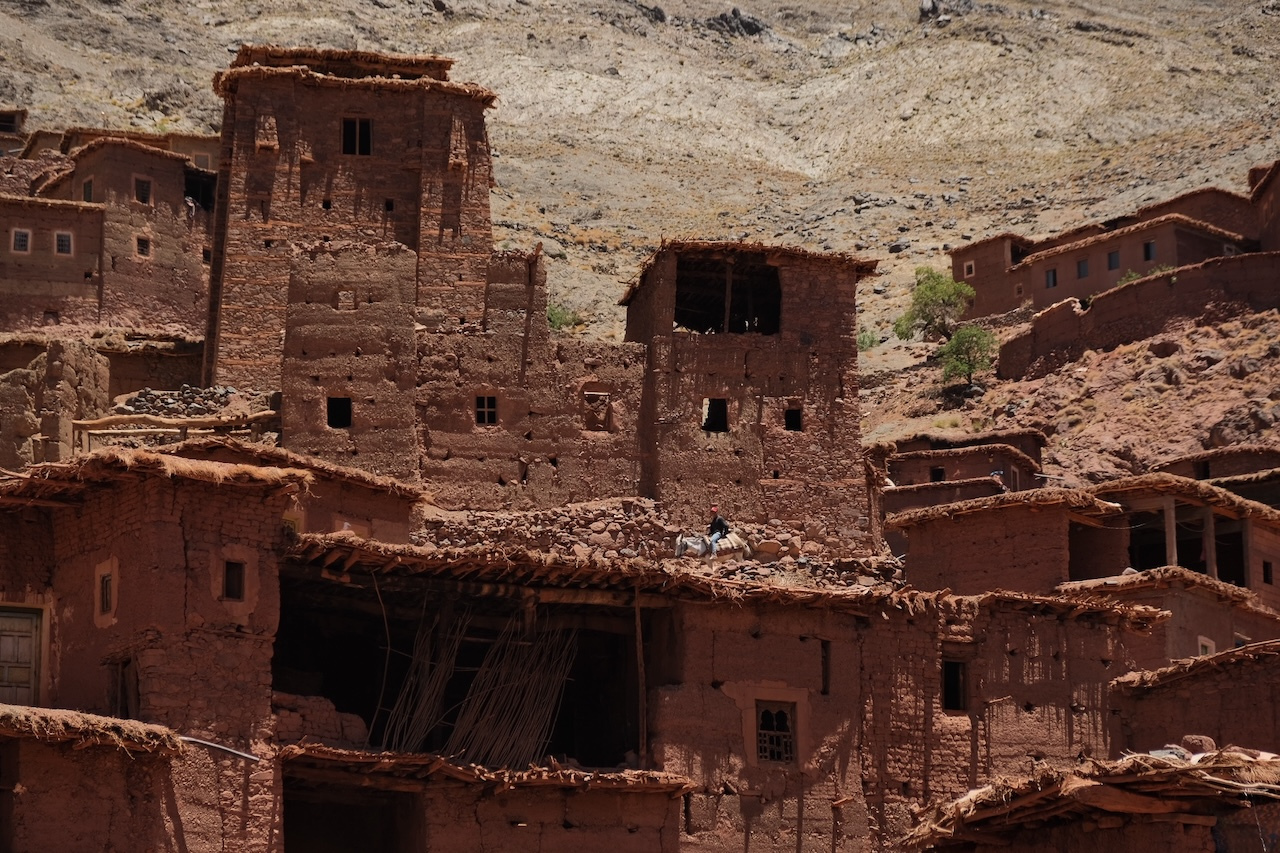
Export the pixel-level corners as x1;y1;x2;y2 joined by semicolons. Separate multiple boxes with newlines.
904;506;1070;596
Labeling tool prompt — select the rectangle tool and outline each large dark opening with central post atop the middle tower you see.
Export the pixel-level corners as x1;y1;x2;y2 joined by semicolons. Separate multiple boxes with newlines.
676;252;782;334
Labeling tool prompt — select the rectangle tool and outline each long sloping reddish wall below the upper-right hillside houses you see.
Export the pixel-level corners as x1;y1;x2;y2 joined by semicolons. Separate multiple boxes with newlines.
998;252;1280;379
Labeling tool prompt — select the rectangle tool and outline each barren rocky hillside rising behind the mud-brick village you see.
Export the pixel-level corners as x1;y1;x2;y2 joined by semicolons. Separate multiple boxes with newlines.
0;0;1280;476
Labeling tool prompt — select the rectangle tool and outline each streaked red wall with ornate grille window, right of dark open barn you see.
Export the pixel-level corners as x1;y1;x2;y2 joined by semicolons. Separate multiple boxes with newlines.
649;599;1128;852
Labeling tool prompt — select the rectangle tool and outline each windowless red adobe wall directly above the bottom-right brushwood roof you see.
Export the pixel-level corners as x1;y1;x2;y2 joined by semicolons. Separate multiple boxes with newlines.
1111;656;1280;756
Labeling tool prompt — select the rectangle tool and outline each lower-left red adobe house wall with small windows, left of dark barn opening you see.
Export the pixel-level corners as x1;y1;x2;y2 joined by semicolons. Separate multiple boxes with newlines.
41;478;287;850
